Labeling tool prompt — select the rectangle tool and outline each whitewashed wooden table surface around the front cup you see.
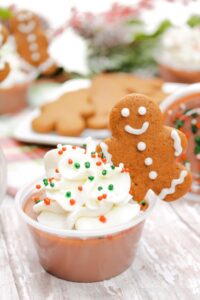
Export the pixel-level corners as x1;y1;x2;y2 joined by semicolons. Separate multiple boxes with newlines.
0;196;200;300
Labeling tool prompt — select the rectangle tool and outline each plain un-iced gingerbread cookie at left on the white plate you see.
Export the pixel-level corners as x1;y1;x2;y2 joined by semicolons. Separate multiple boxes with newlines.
32;89;94;136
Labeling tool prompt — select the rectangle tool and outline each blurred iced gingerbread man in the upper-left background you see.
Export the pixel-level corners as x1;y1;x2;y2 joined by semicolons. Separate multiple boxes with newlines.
11;10;57;75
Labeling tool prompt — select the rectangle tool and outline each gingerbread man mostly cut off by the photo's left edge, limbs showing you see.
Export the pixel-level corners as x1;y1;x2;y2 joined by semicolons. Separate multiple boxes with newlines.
0;24;10;82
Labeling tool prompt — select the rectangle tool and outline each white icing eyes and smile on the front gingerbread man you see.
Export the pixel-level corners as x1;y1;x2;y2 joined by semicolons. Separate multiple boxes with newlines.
121;106;149;135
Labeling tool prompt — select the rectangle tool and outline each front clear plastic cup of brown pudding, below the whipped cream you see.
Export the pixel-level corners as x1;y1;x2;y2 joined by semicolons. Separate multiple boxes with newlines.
16;181;157;282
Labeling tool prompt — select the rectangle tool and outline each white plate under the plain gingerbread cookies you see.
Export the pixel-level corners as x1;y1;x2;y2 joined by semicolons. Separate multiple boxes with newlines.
13;79;188;145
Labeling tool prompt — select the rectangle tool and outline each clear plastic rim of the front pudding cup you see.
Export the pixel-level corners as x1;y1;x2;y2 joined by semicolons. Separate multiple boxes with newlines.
15;178;158;239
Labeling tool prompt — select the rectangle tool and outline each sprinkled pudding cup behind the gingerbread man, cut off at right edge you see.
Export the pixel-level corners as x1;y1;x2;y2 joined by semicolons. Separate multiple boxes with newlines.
160;83;200;201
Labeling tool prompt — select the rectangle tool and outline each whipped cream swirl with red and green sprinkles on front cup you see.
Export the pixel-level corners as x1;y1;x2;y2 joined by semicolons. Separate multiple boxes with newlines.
33;139;142;231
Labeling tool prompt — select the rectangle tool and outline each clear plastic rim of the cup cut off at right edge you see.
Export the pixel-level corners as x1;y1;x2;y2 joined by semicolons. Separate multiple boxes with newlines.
160;83;200;112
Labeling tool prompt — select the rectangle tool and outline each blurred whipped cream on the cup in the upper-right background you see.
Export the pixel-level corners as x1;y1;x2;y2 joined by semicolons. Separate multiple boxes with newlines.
156;25;200;71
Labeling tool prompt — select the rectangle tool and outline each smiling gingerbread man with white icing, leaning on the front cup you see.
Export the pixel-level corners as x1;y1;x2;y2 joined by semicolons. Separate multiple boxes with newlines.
100;94;192;201
